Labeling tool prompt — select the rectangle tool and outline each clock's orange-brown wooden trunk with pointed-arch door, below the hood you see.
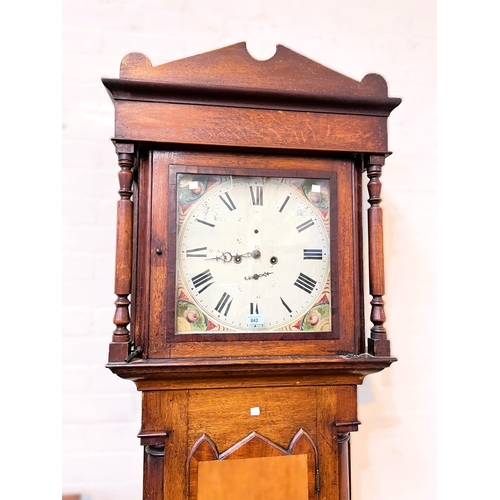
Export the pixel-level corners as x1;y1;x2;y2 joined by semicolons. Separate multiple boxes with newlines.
139;385;359;500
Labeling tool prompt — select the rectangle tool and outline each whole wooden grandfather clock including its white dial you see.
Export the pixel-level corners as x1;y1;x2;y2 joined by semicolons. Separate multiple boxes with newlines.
103;43;401;500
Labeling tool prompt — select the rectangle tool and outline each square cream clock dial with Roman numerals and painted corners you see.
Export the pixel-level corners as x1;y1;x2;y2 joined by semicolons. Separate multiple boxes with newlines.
177;174;331;333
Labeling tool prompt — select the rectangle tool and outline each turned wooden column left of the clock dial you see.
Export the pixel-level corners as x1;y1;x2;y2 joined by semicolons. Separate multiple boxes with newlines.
109;142;135;362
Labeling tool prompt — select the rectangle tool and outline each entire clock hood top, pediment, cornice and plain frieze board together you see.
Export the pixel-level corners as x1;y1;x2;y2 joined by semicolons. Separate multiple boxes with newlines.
102;42;401;155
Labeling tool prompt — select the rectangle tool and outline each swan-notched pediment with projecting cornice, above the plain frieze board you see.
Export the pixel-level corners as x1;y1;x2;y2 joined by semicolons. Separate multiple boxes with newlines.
102;42;401;117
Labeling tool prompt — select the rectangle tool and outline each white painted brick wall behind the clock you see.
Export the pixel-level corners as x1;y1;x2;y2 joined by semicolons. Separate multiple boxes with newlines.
59;0;436;500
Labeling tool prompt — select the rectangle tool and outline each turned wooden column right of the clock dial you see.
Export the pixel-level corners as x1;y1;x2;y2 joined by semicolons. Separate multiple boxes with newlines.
367;155;391;356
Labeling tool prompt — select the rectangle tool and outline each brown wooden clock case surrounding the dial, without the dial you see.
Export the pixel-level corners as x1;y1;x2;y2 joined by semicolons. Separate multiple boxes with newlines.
102;43;401;500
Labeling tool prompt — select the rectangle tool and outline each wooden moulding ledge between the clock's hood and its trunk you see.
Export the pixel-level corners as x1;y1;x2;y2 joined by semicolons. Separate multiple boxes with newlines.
107;355;396;391
